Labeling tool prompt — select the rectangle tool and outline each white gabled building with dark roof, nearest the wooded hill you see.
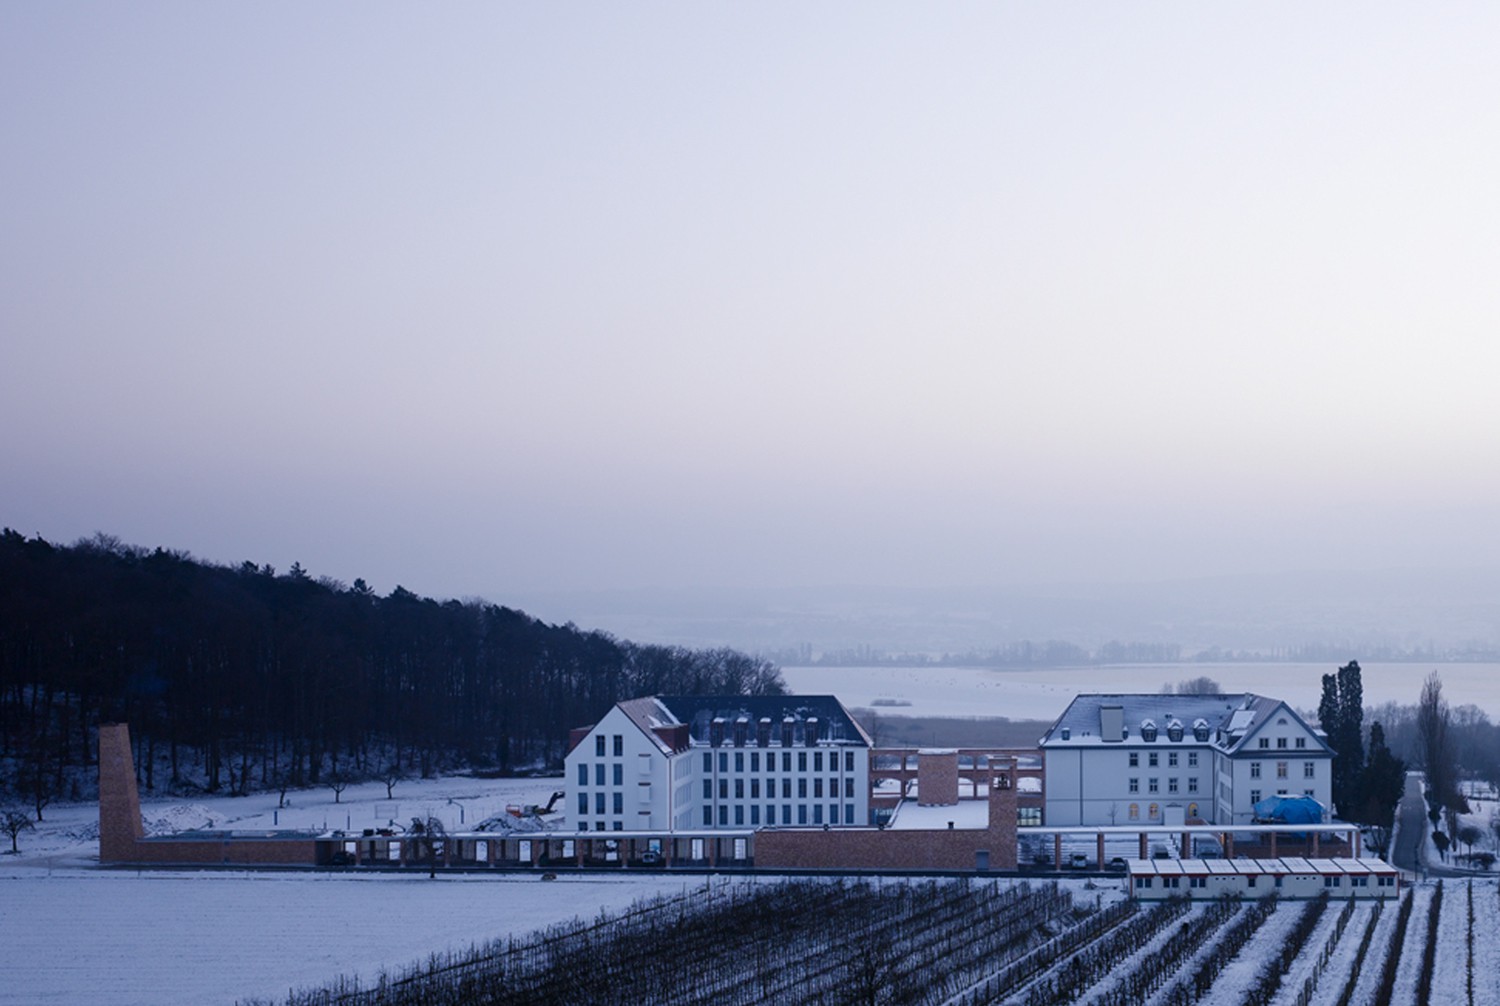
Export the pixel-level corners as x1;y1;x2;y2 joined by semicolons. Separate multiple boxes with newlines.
566;696;870;832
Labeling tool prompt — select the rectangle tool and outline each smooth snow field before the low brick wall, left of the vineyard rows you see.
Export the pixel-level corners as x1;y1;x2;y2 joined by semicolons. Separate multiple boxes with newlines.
0;871;704;1006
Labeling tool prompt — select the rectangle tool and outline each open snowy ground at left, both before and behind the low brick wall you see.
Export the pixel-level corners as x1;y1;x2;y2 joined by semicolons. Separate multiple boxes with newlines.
0;778;702;1006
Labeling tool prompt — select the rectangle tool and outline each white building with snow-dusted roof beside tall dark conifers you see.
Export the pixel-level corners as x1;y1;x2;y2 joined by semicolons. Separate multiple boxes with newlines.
1041;693;1334;826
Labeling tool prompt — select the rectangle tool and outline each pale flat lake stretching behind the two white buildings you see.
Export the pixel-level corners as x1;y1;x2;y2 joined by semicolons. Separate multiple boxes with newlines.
782;663;1500;721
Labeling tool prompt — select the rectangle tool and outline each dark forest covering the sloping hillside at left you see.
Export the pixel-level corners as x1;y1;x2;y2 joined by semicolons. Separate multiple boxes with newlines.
0;529;785;798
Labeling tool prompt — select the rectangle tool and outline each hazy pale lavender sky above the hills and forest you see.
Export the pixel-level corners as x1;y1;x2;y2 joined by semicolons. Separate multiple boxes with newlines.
0;0;1500;601
